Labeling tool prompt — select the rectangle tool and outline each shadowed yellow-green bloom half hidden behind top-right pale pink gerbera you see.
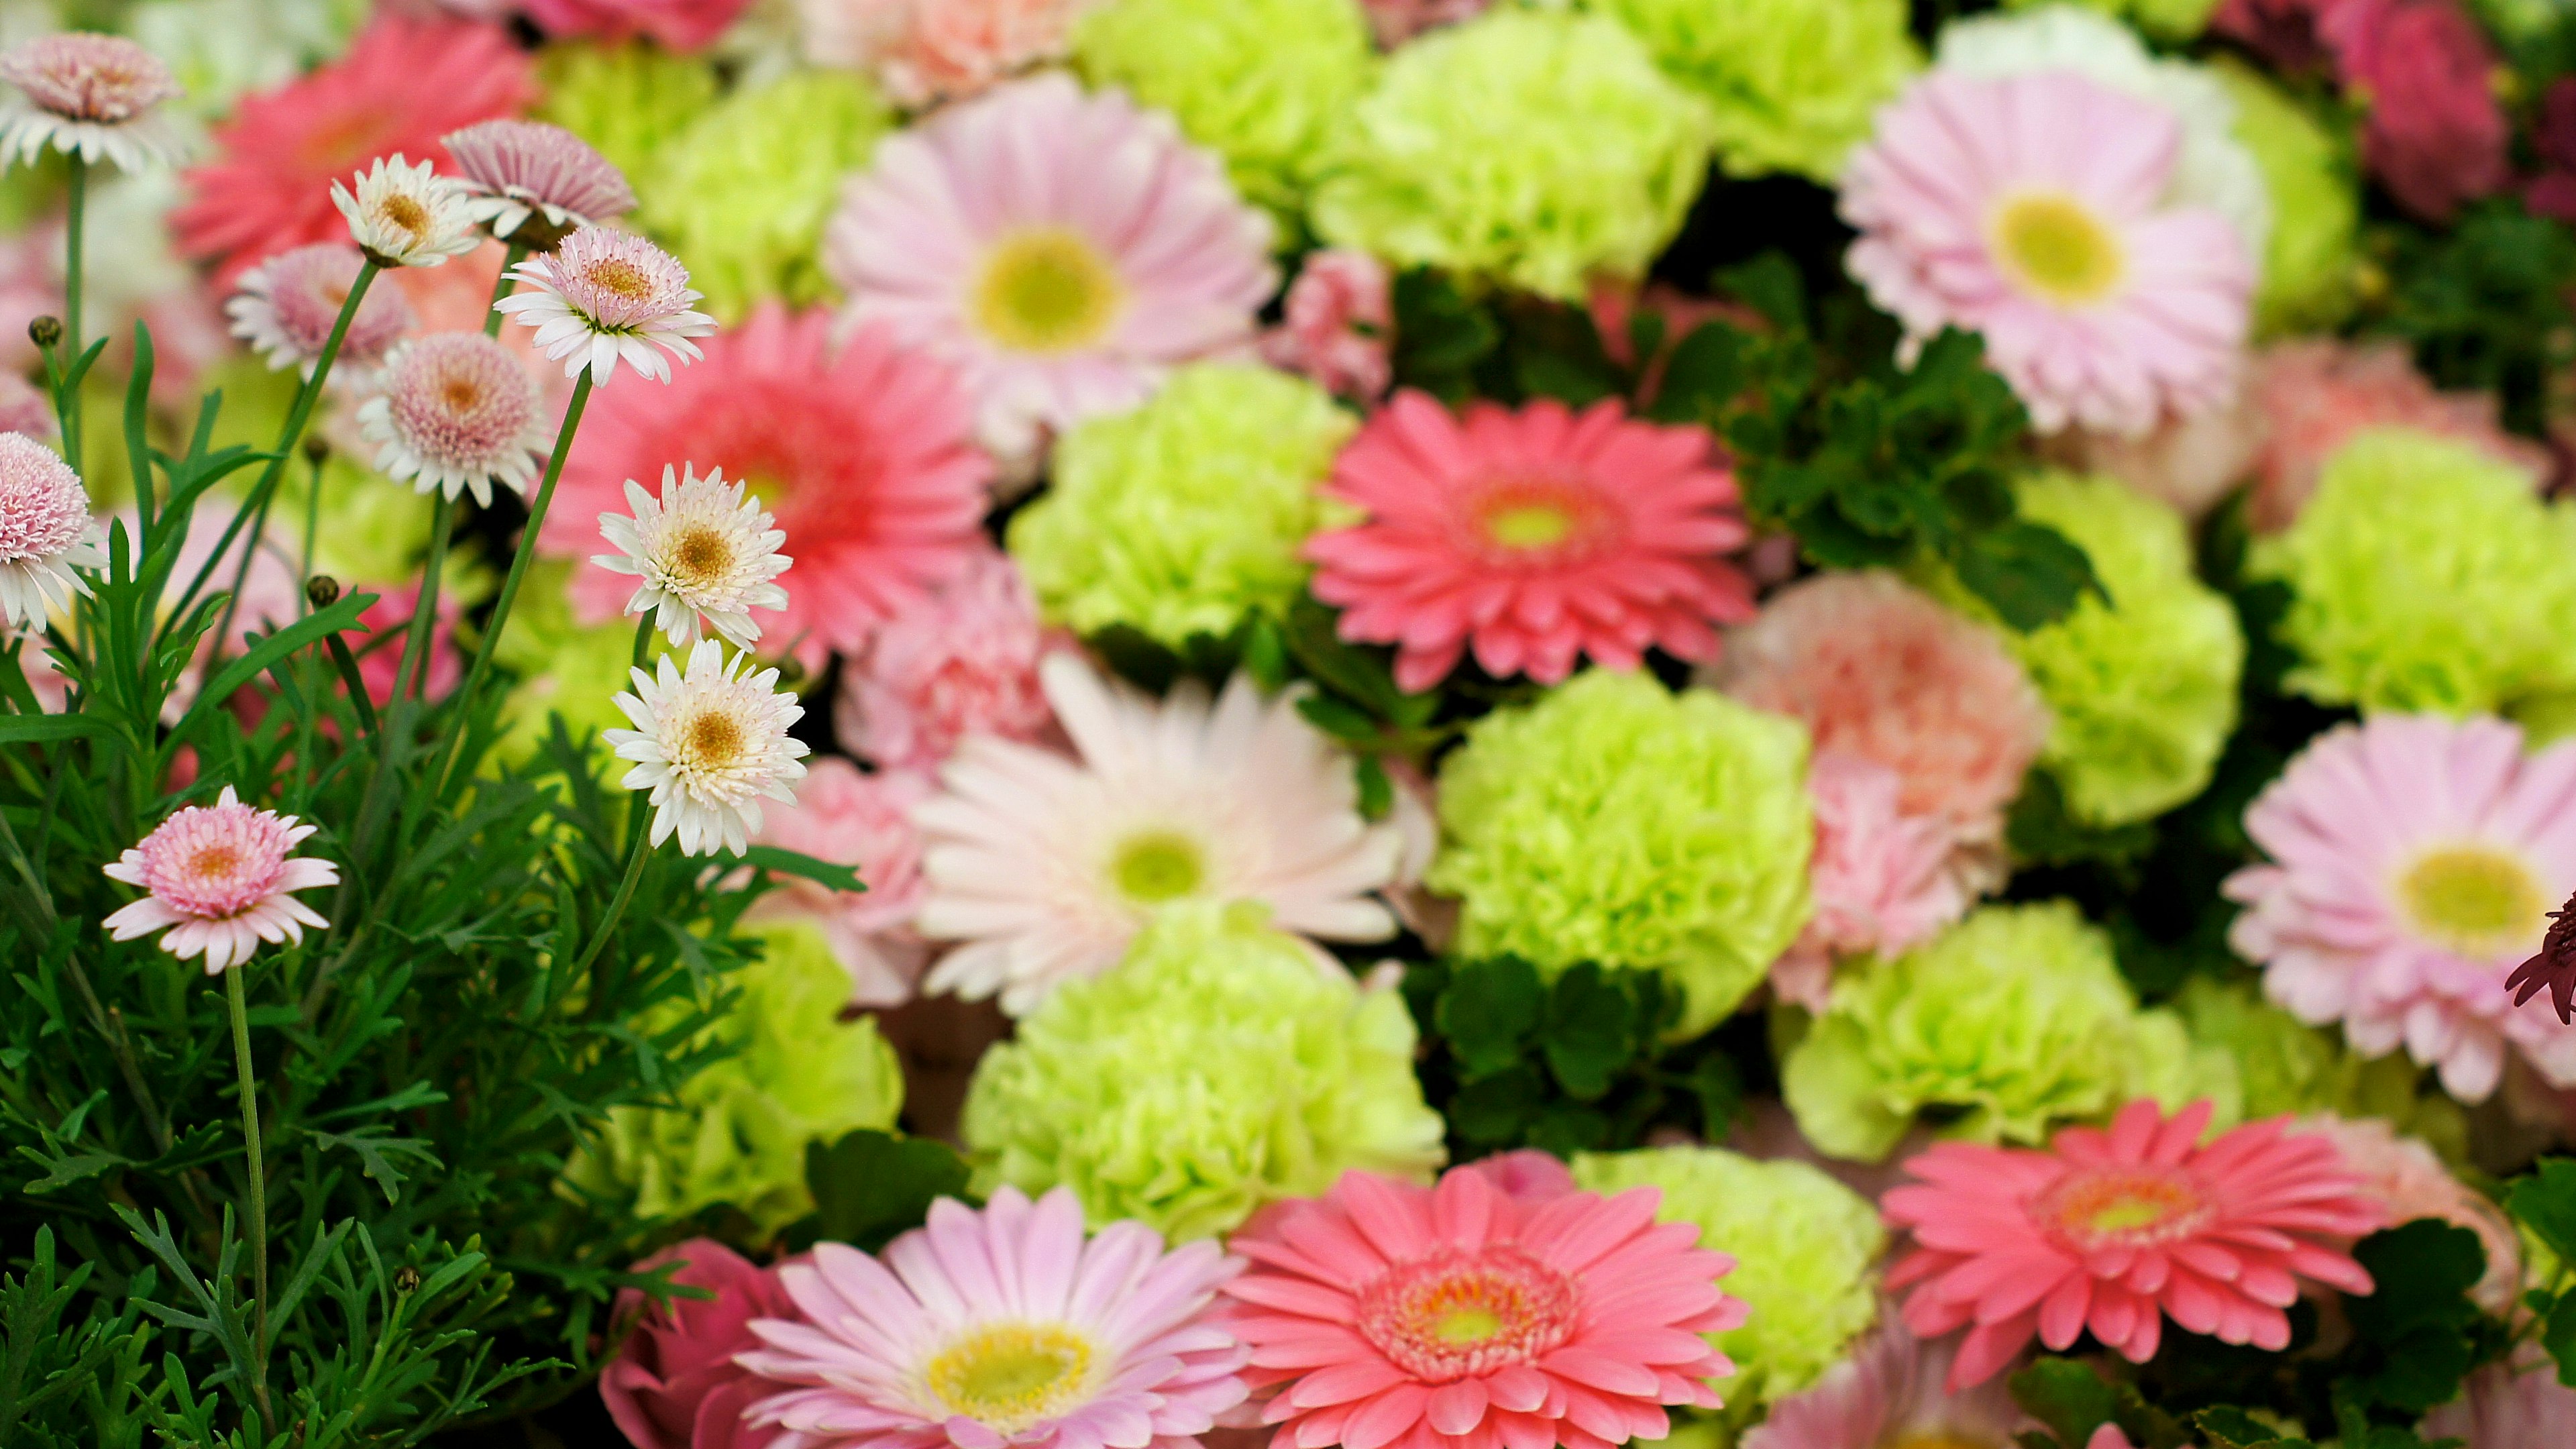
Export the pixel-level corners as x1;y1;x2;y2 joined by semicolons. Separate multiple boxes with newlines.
2208;57;2362;335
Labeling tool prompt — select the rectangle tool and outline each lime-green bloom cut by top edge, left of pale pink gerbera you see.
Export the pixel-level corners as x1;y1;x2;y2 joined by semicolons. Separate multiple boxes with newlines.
1585;0;1924;186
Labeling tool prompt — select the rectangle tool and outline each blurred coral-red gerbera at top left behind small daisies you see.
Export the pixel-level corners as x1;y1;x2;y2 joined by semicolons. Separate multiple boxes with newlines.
170;13;536;288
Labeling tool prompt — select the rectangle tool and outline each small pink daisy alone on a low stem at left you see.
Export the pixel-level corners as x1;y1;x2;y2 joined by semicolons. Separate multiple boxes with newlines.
101;784;340;977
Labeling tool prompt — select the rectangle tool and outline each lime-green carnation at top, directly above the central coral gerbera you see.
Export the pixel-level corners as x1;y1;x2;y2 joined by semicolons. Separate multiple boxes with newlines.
1311;8;1715;302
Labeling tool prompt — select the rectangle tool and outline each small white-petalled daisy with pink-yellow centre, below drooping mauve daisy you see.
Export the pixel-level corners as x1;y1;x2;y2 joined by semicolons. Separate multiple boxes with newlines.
497;227;716;384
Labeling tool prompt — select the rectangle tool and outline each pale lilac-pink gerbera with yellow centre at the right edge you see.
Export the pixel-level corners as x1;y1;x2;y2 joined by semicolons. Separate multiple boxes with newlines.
2223;714;2576;1101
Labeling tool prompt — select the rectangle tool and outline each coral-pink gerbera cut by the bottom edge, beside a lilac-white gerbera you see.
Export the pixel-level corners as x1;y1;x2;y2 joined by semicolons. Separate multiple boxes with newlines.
1226;1168;1747;1449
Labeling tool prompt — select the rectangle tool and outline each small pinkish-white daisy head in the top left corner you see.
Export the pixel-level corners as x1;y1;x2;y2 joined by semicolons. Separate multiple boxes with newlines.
0;31;188;170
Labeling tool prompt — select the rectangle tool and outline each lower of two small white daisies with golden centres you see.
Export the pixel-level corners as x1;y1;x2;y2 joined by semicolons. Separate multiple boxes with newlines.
608;639;806;856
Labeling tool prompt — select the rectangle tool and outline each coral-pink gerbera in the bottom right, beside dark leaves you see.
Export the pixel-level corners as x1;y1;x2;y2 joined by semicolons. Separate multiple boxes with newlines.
1880;1101;2383;1390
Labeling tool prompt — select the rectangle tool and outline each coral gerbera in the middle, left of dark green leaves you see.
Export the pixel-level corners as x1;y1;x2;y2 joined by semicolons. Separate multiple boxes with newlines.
1306;392;1754;688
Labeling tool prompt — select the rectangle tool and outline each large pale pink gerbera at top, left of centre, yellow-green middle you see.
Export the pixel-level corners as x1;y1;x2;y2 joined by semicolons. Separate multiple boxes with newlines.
824;74;1278;464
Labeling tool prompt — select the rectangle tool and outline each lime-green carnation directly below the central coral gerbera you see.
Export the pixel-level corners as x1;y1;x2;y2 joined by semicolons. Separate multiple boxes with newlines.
1430;667;1813;1034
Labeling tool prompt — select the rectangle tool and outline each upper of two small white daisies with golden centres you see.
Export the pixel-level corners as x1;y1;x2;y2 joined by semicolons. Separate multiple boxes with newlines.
590;464;796;650
